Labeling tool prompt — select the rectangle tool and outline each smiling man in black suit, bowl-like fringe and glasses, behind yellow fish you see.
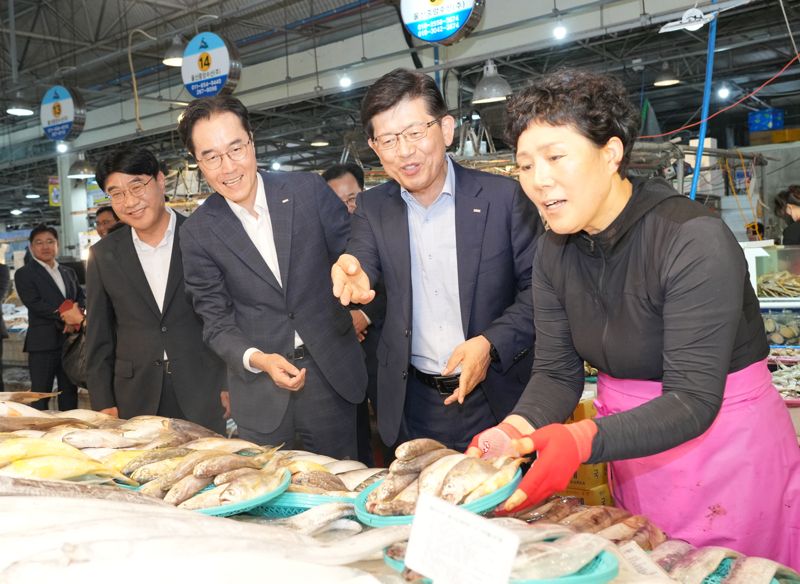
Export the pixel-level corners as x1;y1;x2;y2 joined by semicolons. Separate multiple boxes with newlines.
86;146;226;432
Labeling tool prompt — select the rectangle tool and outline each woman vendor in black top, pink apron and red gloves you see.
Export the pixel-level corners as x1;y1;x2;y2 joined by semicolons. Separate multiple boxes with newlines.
468;70;800;568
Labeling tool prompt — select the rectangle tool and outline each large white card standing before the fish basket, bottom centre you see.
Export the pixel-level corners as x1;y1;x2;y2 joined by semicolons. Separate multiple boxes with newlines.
405;493;519;584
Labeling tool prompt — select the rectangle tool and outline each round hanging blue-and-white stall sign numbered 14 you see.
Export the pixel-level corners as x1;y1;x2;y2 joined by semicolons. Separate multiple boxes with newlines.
181;32;242;97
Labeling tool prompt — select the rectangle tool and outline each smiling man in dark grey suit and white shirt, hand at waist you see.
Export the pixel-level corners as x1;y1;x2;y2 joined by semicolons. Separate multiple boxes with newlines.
178;96;367;458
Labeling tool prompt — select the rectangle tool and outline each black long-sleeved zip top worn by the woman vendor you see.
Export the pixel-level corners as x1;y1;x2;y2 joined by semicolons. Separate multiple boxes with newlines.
514;179;769;462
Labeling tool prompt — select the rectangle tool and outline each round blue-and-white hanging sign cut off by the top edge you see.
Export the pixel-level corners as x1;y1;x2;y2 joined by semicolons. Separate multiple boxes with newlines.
400;0;485;45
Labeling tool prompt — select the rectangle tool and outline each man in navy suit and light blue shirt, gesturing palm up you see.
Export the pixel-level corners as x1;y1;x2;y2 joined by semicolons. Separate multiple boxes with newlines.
331;69;542;450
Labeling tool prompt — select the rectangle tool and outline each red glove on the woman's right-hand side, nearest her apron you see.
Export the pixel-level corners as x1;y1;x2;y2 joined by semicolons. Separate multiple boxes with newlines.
503;420;597;513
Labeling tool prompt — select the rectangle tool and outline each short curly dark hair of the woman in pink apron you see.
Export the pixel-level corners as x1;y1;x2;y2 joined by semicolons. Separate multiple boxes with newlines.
506;69;640;177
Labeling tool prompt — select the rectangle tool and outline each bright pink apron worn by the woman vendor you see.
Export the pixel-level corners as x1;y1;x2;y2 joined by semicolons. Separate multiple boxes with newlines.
595;361;800;570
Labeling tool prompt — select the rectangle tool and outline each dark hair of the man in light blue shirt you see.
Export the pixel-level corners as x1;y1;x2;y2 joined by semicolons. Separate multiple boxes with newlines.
361;68;447;138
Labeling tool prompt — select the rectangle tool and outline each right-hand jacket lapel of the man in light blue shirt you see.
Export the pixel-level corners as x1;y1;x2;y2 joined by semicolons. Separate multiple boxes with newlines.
453;163;489;335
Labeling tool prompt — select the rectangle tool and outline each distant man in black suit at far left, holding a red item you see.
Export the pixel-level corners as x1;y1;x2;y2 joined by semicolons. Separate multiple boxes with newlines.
14;225;85;411
